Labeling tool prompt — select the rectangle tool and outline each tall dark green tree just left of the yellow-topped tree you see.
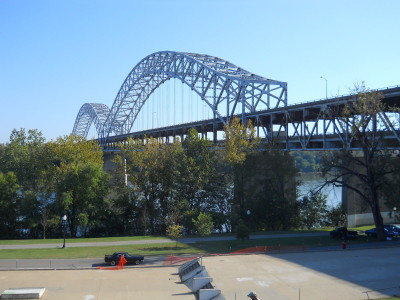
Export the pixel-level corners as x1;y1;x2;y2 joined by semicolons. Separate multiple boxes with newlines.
176;129;230;232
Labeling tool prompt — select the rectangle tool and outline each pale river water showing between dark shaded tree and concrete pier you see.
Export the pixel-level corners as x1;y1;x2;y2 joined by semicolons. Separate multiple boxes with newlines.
297;173;342;207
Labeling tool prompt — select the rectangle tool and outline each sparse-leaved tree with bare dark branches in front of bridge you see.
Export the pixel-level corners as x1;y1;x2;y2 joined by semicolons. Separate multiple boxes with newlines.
321;88;399;240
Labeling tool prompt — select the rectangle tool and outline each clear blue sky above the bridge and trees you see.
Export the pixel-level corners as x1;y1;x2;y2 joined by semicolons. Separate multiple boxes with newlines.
0;0;400;143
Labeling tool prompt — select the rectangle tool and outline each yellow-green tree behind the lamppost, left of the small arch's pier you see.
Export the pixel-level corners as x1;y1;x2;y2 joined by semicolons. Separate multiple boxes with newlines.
47;136;109;236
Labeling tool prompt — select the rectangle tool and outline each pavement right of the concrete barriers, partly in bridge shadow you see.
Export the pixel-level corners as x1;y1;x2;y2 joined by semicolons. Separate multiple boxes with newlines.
203;247;400;300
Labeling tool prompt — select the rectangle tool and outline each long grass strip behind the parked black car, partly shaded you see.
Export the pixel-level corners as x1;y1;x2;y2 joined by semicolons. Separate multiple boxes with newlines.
0;234;390;259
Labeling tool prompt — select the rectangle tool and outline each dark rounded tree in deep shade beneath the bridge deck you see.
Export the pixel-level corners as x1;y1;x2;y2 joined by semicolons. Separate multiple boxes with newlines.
244;148;299;230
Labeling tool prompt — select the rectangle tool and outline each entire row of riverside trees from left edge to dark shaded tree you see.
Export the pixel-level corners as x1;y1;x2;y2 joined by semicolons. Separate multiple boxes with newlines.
0;120;304;238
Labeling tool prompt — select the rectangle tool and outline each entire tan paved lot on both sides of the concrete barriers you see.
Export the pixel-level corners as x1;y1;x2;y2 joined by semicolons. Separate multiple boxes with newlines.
0;247;400;300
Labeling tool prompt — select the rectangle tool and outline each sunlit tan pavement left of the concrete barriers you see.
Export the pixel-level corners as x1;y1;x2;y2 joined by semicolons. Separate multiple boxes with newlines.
0;267;195;300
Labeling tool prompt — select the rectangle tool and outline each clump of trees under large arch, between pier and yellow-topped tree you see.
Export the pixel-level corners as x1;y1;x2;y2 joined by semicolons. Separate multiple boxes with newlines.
115;129;230;234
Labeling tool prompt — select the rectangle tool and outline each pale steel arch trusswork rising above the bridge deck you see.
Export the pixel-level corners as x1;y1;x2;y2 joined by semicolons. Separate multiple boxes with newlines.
72;51;287;145
